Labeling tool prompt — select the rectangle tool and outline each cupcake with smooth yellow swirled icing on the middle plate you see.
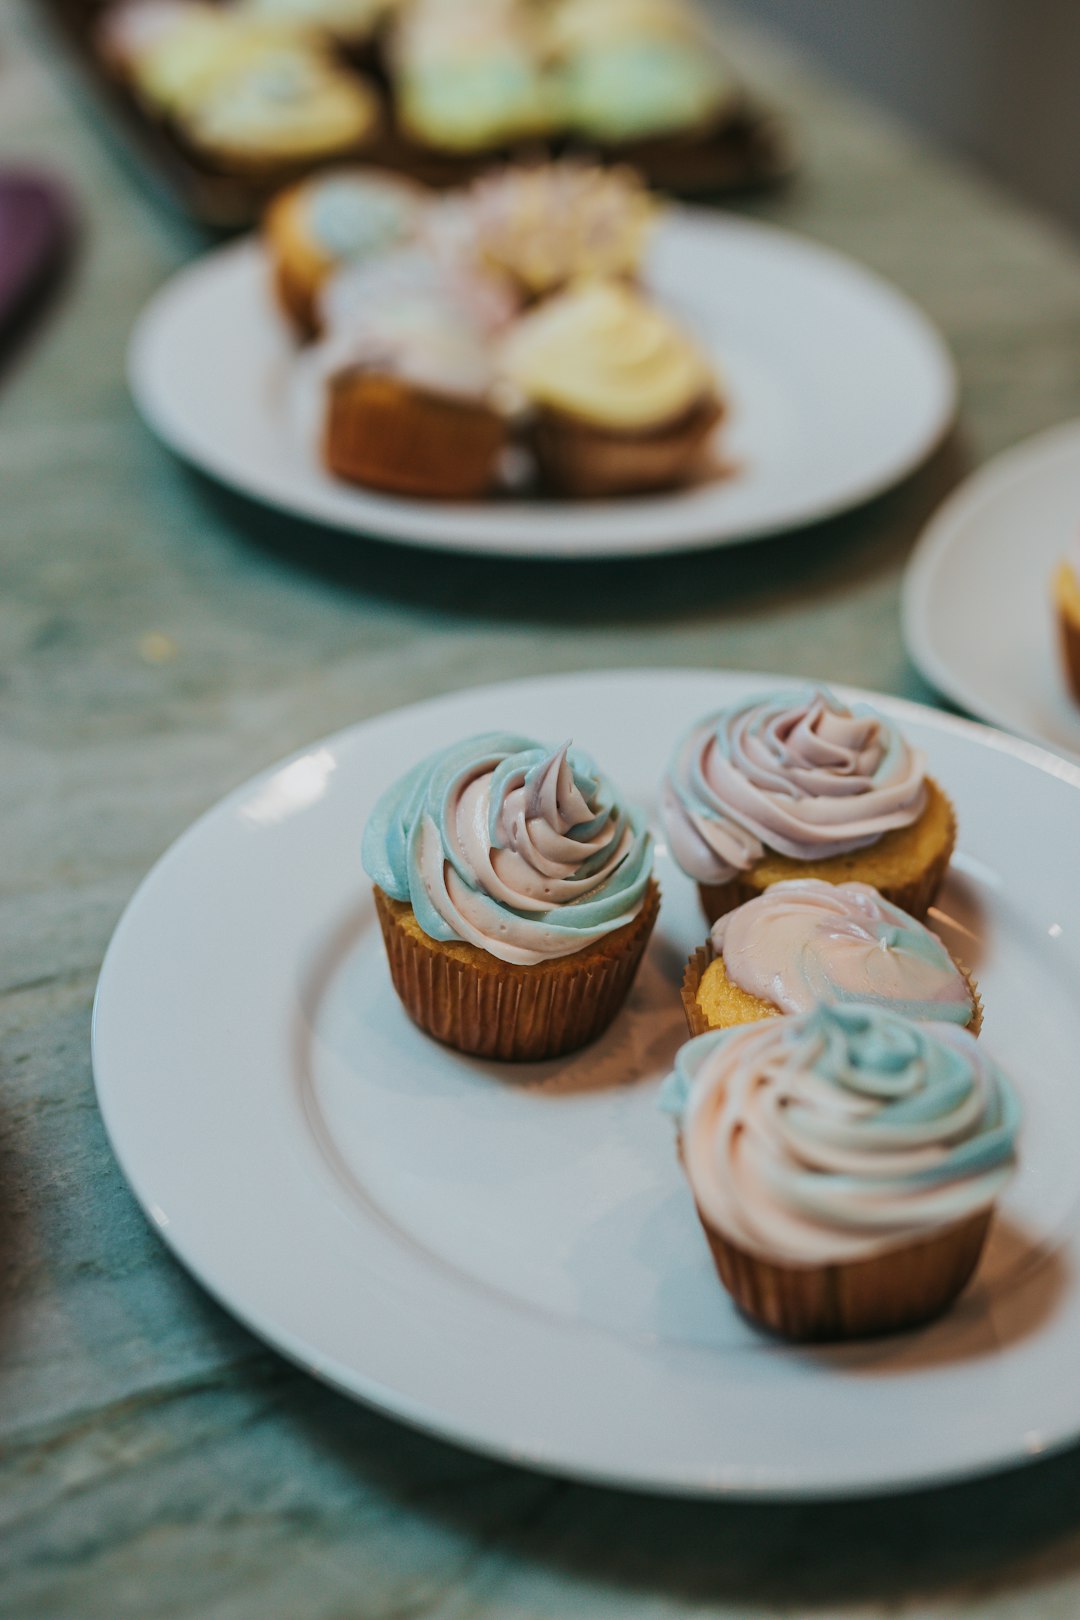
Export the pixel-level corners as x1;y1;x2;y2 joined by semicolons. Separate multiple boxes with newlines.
502;280;724;496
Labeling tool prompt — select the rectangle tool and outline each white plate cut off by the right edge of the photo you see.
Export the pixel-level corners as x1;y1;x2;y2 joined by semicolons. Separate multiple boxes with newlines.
904;421;1080;758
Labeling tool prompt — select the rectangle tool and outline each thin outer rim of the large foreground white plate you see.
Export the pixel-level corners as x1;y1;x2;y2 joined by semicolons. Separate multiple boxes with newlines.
91;666;1080;1502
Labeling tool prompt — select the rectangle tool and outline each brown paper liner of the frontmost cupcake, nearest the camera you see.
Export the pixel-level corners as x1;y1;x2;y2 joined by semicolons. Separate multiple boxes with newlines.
698;1210;993;1343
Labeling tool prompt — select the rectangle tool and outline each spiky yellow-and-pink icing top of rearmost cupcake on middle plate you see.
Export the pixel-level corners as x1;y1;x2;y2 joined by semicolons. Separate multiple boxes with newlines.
444;159;656;296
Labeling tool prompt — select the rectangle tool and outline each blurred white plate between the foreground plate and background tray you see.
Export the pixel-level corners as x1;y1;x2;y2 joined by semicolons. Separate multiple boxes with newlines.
130;209;955;557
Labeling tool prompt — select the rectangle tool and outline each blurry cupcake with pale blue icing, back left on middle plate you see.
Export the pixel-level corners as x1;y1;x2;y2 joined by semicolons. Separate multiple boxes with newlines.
262;168;427;337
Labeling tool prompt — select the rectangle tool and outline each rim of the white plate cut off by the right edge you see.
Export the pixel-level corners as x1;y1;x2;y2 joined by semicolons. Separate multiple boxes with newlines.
900;418;1080;760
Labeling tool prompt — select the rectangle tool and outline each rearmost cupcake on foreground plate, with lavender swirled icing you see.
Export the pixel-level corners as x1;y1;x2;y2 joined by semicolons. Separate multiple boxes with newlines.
661;687;957;922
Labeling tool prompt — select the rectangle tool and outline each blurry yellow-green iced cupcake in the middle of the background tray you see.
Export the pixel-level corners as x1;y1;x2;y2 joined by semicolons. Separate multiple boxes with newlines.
390;0;555;157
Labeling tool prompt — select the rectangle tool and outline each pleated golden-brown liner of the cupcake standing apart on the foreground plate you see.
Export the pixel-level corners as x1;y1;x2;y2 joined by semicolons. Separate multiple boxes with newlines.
376;880;661;1063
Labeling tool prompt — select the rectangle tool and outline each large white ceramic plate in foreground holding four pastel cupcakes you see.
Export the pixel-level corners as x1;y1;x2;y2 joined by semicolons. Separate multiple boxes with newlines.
94;671;1080;1495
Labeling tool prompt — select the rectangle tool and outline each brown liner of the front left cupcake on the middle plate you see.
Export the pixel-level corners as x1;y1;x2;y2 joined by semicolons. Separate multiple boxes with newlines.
324;366;507;499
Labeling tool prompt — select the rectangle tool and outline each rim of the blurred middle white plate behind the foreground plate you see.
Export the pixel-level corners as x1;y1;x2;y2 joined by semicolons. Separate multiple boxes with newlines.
126;204;959;559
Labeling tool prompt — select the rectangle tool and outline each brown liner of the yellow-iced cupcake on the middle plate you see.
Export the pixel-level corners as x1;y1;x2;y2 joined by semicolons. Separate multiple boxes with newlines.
533;395;724;499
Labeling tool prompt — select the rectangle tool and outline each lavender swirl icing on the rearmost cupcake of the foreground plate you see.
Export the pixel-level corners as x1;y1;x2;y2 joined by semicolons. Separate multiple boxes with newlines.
661;687;926;883
